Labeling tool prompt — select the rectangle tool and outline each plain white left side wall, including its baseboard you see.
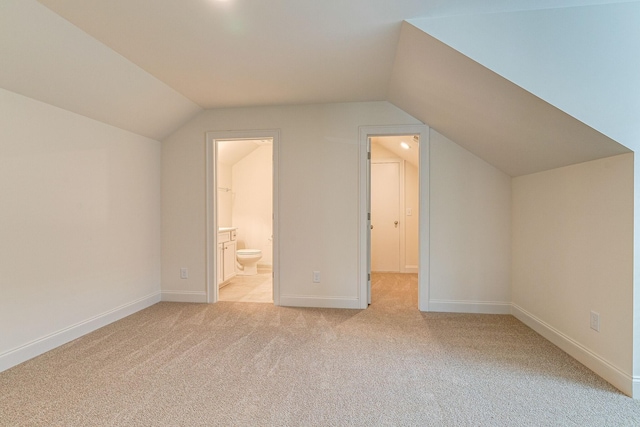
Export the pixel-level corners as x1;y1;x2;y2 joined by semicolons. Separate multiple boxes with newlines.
0;89;161;370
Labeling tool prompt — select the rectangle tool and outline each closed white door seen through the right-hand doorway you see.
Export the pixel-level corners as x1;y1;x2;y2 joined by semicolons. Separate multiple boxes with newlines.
371;162;400;272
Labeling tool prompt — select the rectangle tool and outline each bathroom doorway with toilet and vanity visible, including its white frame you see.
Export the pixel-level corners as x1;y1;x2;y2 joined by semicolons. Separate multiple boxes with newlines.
202;132;277;304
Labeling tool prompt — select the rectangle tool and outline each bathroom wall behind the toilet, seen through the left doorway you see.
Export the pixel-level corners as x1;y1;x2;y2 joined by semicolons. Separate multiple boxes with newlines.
232;145;273;266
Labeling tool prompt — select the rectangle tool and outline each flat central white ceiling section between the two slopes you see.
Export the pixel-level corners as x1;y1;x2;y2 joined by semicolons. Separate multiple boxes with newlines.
35;0;615;108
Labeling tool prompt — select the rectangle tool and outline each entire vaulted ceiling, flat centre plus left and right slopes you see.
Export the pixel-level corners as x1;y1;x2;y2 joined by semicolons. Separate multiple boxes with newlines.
0;0;628;175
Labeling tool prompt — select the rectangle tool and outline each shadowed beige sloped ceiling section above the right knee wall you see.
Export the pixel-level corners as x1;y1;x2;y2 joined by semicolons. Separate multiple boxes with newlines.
389;23;629;176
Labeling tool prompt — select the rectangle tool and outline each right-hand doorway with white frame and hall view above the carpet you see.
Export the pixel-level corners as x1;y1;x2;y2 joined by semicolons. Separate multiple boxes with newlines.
359;125;429;311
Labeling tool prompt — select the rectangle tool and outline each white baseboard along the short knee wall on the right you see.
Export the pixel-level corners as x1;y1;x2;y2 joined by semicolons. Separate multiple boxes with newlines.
511;304;640;399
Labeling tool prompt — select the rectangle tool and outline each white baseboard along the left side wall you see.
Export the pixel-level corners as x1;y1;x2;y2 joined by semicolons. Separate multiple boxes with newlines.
0;292;160;372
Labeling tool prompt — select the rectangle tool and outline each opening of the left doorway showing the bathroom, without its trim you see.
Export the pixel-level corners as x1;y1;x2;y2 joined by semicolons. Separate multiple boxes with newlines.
215;138;273;303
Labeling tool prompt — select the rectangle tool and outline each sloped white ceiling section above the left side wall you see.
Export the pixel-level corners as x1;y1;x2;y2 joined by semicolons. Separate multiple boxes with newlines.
0;0;201;140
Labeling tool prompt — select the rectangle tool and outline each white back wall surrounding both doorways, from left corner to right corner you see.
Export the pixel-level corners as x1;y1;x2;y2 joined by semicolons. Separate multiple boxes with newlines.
162;102;511;313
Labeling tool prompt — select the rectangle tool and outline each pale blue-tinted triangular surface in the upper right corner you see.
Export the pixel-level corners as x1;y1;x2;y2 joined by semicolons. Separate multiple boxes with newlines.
409;1;640;149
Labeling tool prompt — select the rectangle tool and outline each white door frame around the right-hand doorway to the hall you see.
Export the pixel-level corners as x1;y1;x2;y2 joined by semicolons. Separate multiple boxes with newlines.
358;125;430;311
